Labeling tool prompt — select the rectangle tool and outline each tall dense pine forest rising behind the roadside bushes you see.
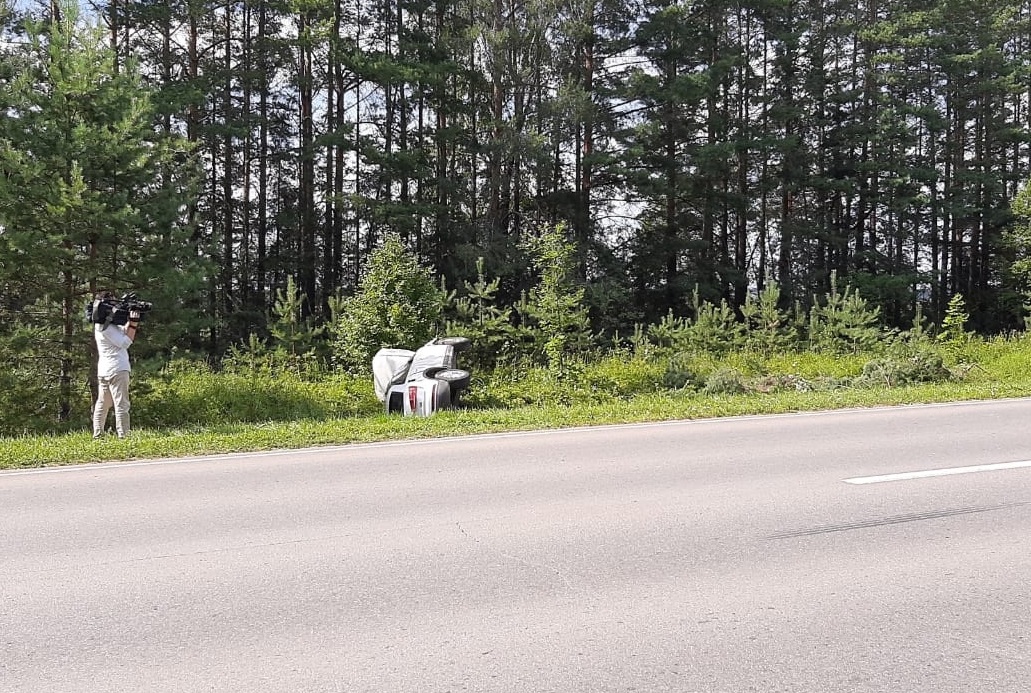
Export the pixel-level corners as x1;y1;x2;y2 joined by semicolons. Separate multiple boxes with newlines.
0;0;1031;433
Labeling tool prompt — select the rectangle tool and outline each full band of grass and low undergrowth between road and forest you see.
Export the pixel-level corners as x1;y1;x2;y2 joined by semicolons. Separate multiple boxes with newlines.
0;335;1031;468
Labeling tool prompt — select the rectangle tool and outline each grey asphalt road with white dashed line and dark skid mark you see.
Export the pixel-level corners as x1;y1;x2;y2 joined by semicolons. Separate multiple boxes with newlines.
0;399;1031;693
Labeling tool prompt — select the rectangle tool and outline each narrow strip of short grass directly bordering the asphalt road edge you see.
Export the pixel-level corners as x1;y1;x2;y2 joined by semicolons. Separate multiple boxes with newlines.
0;368;1031;469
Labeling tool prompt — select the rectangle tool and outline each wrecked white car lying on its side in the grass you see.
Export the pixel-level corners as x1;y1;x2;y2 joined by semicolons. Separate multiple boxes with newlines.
372;337;469;417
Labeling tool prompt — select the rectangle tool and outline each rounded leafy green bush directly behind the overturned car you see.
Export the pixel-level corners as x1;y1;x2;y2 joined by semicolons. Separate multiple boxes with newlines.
330;234;444;374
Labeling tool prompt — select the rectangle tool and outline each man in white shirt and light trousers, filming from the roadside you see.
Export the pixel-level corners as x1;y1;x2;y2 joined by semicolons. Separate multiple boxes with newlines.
93;291;139;438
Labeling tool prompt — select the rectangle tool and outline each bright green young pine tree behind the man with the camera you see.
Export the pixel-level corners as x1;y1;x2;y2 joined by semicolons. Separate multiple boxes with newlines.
0;4;198;421
